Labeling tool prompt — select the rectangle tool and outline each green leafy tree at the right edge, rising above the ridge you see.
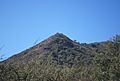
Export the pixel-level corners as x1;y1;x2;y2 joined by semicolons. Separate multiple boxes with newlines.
93;35;120;81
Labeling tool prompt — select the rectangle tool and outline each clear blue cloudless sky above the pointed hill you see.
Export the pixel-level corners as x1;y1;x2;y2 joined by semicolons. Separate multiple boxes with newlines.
0;0;120;57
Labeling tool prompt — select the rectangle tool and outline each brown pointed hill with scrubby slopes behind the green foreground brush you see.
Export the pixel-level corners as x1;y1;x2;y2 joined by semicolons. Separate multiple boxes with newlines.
1;33;95;65
